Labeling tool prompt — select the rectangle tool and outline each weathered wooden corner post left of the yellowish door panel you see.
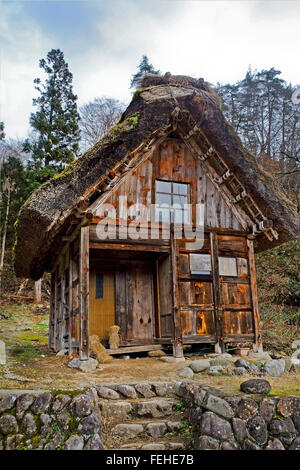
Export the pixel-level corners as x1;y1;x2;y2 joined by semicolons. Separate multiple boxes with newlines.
79;226;89;359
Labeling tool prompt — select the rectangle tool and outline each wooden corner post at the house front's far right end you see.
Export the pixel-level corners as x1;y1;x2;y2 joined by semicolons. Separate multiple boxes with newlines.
247;238;263;352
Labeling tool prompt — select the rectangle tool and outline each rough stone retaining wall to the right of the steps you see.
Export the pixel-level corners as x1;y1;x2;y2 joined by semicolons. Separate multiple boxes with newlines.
177;380;300;450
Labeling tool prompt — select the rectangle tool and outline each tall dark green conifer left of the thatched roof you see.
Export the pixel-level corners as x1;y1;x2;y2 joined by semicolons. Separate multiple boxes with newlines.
24;49;80;175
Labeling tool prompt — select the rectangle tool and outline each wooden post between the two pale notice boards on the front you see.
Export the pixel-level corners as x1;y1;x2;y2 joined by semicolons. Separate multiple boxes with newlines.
210;232;225;354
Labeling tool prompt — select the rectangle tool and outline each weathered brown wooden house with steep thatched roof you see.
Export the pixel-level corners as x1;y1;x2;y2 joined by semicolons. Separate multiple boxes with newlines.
15;74;299;359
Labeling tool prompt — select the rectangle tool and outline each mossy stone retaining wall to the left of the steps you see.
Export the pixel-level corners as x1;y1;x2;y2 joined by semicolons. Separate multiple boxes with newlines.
0;389;103;450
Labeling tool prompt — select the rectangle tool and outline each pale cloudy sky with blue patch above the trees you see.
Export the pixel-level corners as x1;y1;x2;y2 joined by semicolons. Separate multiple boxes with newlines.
0;0;300;138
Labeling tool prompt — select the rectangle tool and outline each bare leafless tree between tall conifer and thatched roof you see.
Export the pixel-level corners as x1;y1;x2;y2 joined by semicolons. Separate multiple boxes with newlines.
79;96;125;150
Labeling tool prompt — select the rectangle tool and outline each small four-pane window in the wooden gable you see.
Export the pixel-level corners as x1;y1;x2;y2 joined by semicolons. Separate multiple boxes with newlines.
155;180;190;223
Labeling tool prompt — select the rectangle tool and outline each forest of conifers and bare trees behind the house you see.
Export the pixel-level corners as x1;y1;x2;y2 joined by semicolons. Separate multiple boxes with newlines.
0;50;300;350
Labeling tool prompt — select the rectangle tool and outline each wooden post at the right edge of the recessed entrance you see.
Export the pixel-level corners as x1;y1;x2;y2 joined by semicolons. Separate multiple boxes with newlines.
170;225;183;357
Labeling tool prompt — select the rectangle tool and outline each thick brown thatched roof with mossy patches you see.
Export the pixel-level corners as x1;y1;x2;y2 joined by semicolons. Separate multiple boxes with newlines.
15;74;299;279
